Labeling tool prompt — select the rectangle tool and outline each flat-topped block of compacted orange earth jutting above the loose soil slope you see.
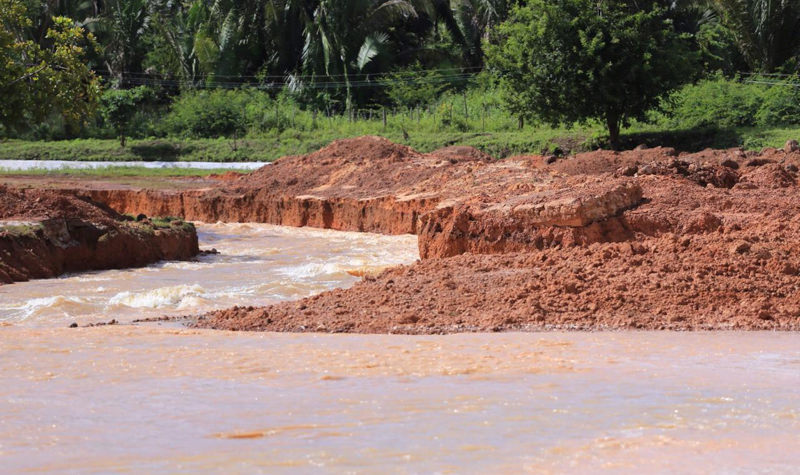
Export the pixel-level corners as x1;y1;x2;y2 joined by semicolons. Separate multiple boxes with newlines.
419;176;642;259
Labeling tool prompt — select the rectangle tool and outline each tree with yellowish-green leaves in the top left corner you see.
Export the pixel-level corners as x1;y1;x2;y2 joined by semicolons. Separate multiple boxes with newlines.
0;0;100;134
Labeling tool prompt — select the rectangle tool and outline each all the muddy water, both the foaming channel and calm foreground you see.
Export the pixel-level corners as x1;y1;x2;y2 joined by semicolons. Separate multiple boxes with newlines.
0;224;800;473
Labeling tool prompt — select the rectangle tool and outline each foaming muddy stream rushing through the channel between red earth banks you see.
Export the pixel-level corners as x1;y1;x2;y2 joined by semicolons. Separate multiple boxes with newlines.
0;223;418;327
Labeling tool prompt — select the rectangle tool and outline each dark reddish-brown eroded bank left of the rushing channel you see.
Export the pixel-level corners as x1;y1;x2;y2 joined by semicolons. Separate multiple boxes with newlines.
0;185;199;284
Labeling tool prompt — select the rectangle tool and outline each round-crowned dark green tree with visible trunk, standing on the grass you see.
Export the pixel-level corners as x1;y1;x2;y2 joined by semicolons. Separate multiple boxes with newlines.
487;0;697;146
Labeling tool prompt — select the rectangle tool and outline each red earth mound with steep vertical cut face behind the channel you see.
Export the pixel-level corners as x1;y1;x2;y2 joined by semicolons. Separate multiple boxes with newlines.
83;137;500;234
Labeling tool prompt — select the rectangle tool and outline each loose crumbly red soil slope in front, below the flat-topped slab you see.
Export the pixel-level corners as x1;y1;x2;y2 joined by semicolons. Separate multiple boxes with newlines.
198;176;800;333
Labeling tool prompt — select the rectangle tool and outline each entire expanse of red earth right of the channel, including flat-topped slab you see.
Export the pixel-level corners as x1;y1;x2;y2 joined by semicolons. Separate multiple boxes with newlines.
192;138;800;333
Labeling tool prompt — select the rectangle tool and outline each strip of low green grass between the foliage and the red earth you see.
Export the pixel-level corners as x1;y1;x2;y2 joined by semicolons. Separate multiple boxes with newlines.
0;121;800;165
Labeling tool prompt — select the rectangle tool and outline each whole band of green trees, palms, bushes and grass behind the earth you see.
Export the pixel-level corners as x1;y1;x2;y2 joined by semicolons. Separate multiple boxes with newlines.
0;0;800;150
